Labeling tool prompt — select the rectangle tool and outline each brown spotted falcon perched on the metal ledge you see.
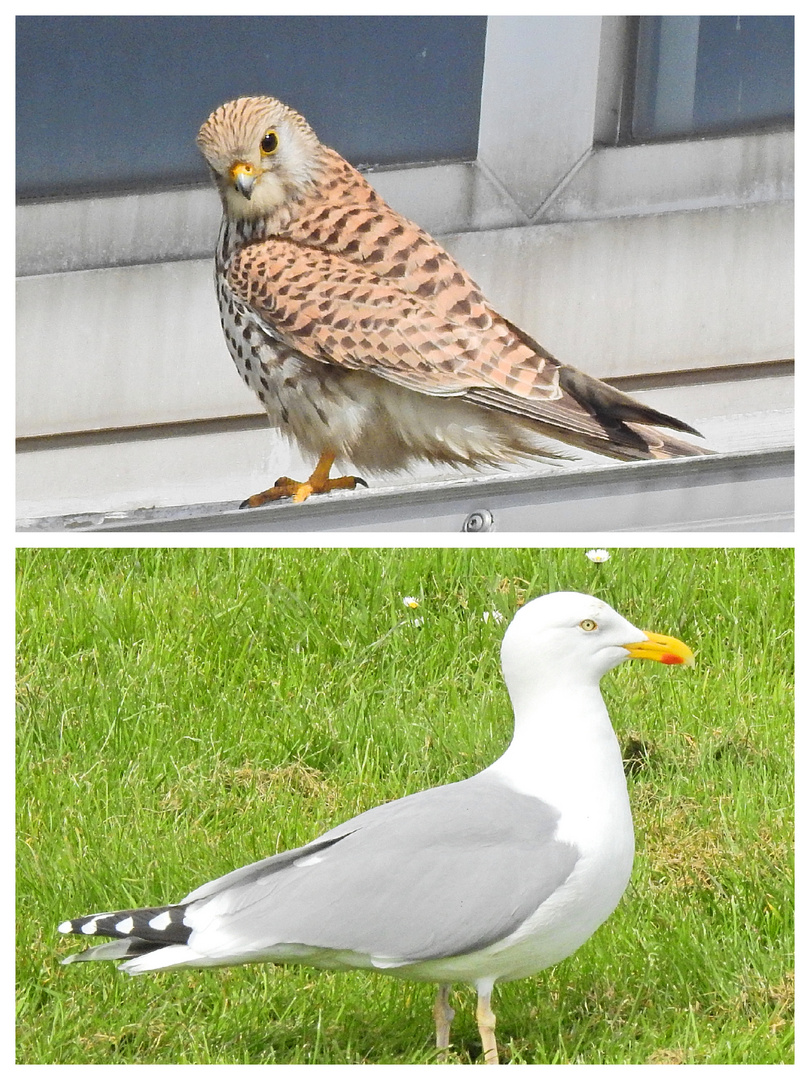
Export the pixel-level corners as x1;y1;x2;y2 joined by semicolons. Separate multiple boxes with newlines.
197;97;707;507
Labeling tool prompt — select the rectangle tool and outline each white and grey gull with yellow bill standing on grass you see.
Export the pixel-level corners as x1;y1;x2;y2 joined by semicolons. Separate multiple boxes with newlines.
58;592;694;1065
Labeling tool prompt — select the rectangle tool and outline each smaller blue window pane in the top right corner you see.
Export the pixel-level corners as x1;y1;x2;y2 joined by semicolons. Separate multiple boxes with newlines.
633;15;794;138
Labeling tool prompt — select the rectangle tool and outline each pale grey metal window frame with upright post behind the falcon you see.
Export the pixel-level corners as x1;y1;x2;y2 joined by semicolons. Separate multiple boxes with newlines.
17;16;794;276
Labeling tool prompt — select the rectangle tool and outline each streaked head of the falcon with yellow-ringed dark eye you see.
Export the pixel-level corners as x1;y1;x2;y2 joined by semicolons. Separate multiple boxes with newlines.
197;97;322;220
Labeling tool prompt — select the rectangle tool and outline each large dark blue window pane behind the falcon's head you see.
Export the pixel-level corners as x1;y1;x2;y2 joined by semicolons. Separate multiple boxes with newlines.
16;16;486;197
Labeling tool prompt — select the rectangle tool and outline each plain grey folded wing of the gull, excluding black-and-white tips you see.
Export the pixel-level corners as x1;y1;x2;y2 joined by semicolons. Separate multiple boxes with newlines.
180;774;578;963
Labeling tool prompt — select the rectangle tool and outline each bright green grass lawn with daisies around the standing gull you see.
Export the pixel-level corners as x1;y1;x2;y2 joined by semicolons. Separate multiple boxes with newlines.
17;549;793;1064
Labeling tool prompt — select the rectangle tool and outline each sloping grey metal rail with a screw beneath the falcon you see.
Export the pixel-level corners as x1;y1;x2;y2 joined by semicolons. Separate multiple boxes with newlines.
19;448;794;535
